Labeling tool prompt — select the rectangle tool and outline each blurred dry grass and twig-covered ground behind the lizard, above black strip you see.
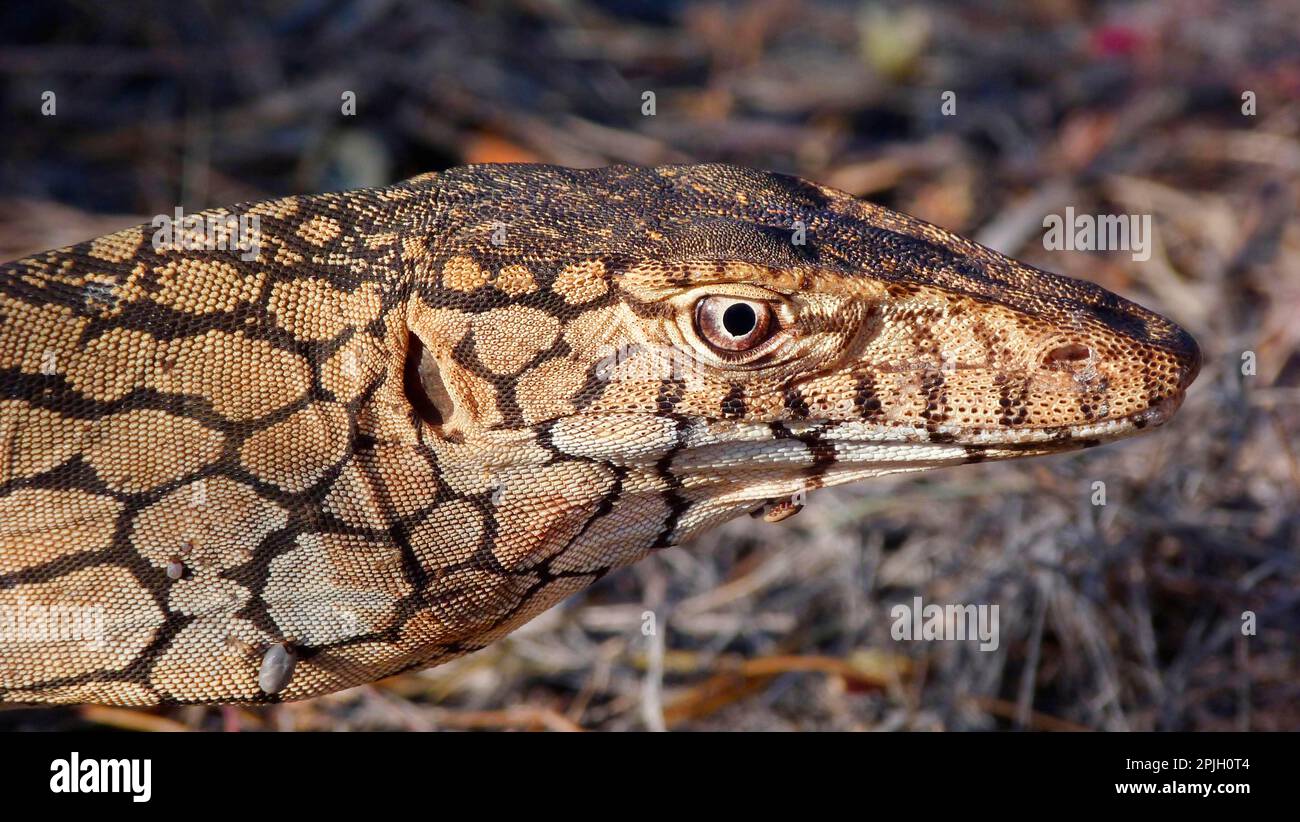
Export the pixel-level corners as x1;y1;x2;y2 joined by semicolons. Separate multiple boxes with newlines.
0;0;1300;731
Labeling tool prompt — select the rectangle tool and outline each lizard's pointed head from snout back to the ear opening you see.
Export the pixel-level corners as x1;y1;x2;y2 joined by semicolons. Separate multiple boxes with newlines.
412;165;1200;541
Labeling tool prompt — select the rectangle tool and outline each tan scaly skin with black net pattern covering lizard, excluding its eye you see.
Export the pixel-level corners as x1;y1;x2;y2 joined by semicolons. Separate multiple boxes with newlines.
0;165;1200;705
